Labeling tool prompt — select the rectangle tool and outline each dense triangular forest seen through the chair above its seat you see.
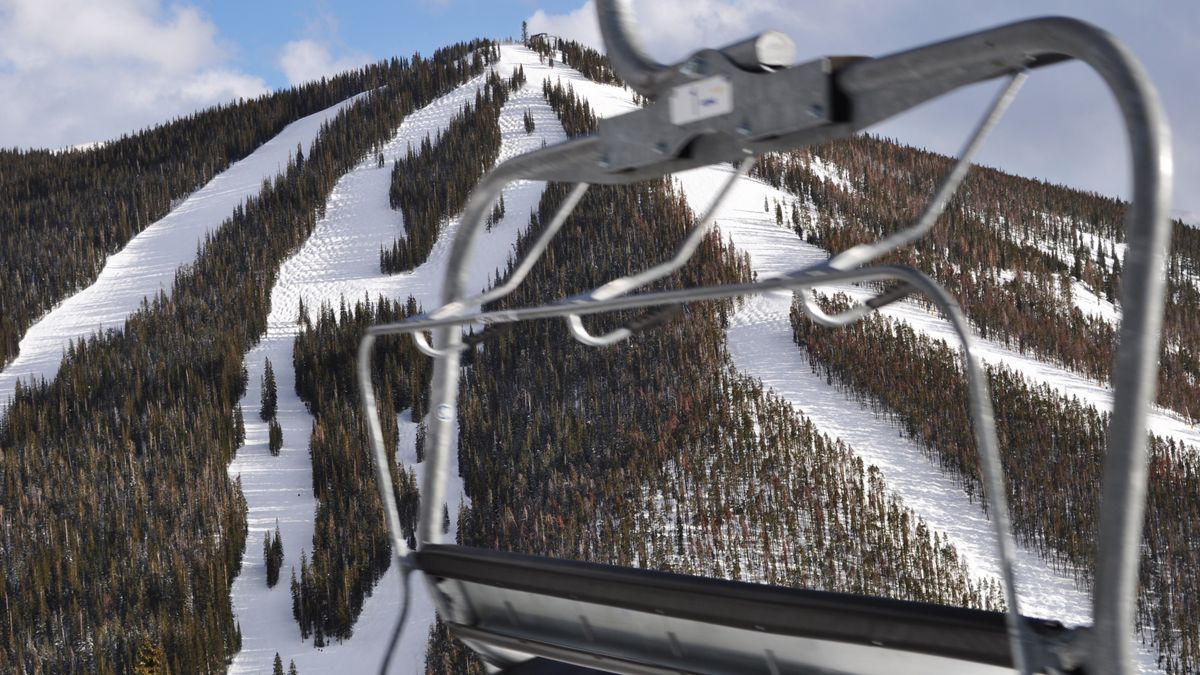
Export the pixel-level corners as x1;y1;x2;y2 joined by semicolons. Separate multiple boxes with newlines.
426;169;1002;673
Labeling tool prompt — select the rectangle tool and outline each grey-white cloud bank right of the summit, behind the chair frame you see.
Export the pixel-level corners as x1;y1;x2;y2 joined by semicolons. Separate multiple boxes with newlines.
528;0;1200;214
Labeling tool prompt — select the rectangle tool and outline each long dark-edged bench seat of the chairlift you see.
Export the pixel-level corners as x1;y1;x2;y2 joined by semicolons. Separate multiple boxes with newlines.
416;544;1067;675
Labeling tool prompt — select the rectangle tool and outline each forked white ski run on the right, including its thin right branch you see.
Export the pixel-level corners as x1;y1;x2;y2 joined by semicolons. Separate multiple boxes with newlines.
508;60;1161;673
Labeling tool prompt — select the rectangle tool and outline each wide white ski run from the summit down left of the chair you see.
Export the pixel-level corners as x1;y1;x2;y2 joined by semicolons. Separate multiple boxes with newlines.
229;46;566;674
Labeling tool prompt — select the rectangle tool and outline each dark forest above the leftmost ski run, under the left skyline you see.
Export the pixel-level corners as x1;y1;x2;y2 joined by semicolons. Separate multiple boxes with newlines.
0;59;417;366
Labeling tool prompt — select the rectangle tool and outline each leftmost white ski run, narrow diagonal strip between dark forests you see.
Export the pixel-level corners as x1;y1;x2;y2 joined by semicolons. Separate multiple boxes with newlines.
0;96;358;414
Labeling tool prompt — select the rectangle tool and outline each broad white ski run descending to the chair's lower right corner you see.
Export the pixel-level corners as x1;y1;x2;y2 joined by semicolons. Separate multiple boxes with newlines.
677;166;1158;673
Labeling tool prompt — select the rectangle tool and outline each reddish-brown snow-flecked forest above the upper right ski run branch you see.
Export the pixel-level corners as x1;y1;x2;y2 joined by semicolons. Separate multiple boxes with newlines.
754;141;1200;422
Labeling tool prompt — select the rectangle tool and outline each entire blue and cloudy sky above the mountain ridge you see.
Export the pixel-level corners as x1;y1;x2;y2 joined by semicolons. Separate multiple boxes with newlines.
0;0;1200;218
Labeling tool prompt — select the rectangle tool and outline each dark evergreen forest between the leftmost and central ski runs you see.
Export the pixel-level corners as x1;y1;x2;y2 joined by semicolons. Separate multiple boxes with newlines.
0;43;490;673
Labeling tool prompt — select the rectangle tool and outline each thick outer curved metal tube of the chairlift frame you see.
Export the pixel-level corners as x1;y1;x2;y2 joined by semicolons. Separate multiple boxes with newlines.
360;14;1172;674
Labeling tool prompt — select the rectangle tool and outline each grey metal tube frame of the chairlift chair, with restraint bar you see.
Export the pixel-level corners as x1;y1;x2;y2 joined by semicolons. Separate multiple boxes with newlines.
359;0;1172;674
